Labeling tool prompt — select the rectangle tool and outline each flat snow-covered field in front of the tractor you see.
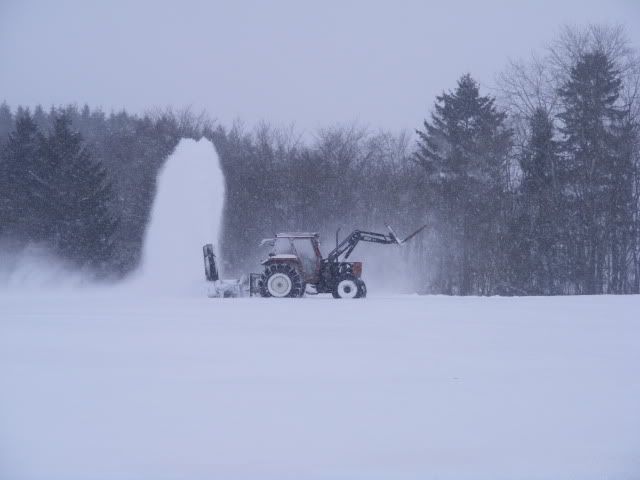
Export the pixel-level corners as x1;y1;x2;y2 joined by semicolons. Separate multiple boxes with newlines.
0;293;640;480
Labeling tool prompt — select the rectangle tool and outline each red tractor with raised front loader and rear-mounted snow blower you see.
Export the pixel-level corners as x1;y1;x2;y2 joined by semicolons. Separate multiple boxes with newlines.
203;225;426;298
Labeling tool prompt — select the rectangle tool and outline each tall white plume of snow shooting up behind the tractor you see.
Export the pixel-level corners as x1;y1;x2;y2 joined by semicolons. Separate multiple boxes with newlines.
135;139;225;295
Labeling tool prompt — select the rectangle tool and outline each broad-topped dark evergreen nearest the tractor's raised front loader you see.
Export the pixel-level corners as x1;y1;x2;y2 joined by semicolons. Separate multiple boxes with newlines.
415;75;510;295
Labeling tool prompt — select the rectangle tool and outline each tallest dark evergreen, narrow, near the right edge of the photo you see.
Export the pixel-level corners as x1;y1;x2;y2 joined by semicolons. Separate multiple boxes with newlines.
559;51;628;294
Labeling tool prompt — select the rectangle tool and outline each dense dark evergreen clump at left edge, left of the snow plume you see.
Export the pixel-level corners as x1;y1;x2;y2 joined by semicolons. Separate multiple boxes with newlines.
0;111;118;274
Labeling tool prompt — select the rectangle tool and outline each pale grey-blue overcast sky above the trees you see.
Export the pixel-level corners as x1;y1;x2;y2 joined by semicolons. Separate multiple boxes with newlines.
0;0;640;131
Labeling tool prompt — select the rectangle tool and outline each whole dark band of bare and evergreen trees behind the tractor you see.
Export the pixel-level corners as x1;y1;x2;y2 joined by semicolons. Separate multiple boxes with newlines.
0;26;640;295
